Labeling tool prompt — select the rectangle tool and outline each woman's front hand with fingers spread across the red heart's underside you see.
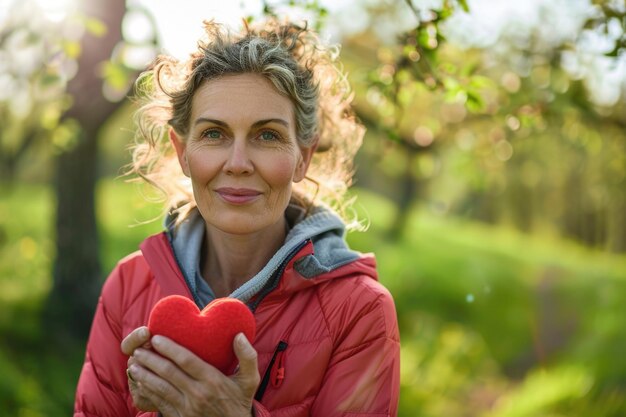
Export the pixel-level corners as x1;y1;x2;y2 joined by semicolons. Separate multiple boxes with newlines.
129;333;260;417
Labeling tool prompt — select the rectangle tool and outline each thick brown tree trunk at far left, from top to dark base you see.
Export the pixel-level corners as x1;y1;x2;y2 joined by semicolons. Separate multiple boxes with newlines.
44;0;126;340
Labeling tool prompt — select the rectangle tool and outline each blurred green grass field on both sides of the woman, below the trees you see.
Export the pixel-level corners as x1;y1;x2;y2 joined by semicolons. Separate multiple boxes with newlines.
0;180;626;417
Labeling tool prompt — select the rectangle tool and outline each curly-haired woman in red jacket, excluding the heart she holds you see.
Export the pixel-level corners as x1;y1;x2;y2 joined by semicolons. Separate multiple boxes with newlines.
74;21;399;417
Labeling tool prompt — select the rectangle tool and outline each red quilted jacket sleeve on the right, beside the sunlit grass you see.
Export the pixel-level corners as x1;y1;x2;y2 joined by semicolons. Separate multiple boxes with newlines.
311;281;400;417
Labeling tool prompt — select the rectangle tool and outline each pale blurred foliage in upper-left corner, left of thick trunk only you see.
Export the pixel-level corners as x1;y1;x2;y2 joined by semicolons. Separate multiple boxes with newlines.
0;1;71;178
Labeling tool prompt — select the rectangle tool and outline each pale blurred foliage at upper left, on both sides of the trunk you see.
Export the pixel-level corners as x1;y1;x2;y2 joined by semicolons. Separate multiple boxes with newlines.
0;0;157;179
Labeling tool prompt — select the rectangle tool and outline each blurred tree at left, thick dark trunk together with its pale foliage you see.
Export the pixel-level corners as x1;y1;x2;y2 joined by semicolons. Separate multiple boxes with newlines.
0;0;158;337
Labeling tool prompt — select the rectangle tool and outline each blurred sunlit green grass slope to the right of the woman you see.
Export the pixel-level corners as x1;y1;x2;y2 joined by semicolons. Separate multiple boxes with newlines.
349;190;626;417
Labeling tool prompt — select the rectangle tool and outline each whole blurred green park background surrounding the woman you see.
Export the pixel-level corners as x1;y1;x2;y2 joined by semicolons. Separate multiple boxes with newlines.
0;0;626;417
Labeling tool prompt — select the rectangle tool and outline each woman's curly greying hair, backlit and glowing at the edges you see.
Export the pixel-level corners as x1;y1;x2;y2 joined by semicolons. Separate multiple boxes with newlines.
129;19;364;224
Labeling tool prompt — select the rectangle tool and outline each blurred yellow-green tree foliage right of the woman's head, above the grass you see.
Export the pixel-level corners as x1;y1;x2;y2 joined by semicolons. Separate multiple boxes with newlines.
336;1;626;252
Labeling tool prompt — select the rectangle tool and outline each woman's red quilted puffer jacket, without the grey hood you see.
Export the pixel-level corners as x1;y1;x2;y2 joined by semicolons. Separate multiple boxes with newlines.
74;233;400;417
